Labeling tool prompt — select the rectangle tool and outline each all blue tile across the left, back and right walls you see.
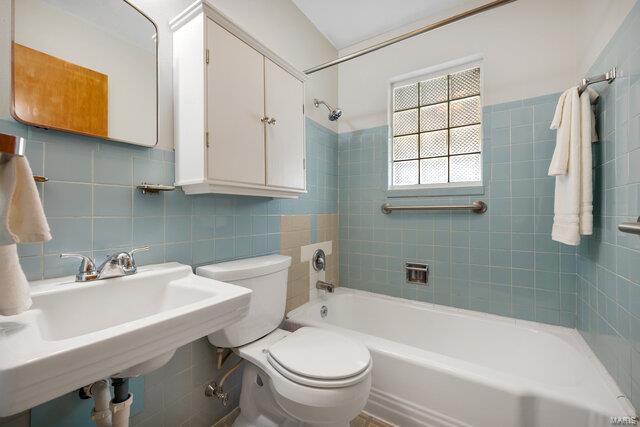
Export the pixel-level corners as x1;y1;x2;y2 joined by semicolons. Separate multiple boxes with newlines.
0;3;640;425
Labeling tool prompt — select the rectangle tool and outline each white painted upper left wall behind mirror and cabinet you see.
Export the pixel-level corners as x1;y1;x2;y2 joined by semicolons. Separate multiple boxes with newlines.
0;0;338;149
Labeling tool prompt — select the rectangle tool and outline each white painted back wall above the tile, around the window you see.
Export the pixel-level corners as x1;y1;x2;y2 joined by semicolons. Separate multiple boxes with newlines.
338;0;577;132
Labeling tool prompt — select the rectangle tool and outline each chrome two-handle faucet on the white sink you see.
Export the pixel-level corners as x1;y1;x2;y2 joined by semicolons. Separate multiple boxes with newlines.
60;246;150;282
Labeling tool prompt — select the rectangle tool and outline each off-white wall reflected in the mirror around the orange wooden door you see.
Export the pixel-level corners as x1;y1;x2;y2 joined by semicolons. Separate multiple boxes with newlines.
14;0;157;146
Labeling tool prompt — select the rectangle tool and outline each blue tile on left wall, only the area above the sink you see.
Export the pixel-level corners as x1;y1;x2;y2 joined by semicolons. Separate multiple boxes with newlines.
0;119;338;280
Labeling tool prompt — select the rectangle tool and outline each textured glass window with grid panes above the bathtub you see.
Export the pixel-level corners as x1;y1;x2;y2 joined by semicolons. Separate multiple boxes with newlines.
391;67;482;187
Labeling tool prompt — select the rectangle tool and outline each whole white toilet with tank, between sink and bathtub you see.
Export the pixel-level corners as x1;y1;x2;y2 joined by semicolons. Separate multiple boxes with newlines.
196;255;371;427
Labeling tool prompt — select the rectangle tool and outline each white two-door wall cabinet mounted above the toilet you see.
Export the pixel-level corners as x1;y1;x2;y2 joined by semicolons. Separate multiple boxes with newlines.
170;1;306;197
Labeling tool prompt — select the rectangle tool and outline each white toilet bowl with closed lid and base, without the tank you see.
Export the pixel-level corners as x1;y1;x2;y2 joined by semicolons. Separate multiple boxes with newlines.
237;328;371;426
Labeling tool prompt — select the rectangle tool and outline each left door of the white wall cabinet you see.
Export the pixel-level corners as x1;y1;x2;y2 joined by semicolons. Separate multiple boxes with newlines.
207;19;265;185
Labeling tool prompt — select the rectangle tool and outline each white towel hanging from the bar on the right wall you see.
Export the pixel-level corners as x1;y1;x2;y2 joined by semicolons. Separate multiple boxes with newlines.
549;87;598;246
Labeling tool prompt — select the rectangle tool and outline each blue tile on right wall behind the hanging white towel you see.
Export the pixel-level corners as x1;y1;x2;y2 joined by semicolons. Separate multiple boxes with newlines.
577;3;640;409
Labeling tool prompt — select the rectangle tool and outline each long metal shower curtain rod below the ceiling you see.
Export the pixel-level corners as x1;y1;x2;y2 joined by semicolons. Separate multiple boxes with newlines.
304;0;516;75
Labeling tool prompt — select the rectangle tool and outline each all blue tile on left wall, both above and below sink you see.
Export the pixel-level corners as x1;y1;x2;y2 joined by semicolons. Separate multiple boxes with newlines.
0;119;338;427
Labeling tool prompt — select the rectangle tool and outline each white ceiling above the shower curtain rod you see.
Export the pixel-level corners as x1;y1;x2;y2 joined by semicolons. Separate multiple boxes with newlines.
293;0;477;50
